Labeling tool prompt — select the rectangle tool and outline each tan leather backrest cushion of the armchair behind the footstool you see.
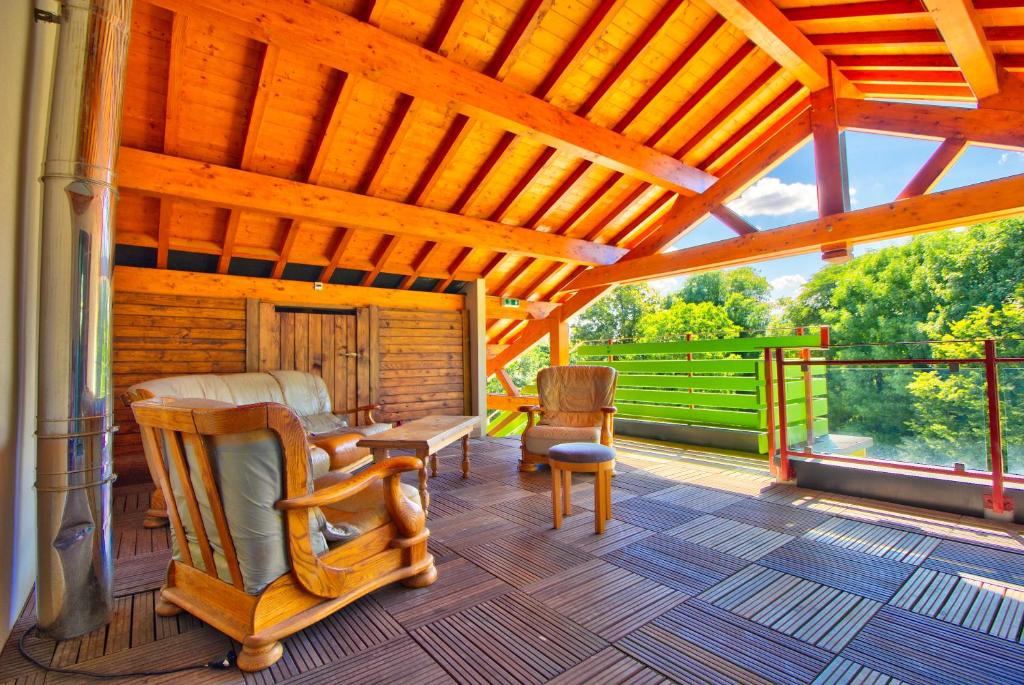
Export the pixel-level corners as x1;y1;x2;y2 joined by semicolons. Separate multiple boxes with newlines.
537;367;618;426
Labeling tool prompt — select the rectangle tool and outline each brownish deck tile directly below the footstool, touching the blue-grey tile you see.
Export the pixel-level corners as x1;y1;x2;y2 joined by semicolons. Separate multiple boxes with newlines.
523;560;686;642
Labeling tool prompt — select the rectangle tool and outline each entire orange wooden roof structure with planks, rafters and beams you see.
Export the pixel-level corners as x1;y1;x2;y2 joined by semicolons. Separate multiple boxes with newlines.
117;0;1024;371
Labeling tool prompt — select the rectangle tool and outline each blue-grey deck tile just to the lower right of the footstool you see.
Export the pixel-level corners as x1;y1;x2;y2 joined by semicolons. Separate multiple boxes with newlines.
604;533;746;595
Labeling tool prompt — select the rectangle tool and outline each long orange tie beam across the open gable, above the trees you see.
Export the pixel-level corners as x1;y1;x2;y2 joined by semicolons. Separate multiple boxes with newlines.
563;174;1024;290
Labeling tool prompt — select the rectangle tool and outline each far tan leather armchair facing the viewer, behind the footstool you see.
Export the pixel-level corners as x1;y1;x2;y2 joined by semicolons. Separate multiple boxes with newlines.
519;367;618;471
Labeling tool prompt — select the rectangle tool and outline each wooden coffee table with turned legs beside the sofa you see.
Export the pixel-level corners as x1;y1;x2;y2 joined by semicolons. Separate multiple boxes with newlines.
356;417;480;511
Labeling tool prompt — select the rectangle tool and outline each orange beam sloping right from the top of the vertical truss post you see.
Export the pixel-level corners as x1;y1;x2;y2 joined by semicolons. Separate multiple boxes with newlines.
837;98;1024;149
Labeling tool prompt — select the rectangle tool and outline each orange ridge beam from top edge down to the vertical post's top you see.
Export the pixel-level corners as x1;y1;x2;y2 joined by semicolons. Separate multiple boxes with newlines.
709;0;830;92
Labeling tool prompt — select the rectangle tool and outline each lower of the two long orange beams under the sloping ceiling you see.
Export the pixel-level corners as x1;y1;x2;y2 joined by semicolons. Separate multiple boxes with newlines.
118;147;625;264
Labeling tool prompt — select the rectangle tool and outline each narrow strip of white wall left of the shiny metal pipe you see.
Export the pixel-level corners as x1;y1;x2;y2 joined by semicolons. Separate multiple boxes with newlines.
0;0;57;642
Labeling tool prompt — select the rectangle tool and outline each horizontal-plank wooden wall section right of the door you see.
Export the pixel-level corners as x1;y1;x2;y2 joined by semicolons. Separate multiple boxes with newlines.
378;309;468;421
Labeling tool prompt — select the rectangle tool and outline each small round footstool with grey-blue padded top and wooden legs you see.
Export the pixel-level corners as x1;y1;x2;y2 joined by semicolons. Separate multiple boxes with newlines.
548;442;615;533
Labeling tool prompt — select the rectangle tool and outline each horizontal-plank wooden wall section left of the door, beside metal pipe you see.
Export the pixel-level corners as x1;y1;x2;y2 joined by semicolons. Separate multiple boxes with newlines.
113;291;246;483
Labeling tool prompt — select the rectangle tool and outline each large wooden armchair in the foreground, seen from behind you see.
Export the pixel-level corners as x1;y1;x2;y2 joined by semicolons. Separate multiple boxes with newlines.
132;398;437;671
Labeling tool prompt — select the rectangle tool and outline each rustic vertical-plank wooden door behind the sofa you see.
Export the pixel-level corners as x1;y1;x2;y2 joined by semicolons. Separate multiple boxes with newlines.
247;302;376;421
